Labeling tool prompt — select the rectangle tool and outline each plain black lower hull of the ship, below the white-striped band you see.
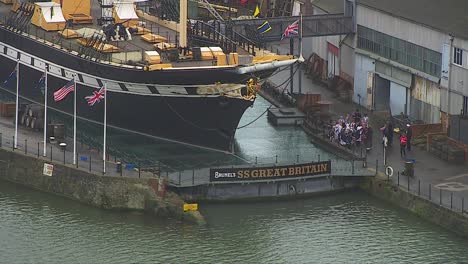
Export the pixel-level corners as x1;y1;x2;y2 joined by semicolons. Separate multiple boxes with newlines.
0;45;253;151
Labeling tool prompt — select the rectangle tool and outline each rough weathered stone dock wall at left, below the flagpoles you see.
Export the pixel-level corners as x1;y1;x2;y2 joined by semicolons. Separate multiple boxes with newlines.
0;149;204;223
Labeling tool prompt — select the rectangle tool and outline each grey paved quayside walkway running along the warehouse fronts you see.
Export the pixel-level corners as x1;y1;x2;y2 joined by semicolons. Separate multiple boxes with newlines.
270;43;468;213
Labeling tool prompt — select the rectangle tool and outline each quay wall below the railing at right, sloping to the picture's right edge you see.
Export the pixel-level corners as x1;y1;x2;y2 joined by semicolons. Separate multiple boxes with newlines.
361;178;468;237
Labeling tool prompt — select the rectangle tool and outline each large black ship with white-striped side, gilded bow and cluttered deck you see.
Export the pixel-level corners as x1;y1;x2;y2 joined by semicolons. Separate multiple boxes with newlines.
0;0;297;151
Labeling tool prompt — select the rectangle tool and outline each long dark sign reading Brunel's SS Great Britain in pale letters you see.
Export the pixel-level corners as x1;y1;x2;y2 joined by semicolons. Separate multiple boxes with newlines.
210;161;331;182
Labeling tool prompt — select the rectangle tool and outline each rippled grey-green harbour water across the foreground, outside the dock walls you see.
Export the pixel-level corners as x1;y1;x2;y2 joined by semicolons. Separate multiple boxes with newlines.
0;181;468;264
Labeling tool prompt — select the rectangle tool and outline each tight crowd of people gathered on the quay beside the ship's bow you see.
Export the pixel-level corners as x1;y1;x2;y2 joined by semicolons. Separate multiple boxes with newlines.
328;109;372;150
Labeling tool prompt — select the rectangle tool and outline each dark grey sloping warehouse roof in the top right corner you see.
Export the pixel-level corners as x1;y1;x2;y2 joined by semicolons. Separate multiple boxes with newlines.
358;0;468;40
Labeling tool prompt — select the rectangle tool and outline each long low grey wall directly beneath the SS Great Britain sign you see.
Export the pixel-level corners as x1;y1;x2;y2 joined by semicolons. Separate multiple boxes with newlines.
179;176;360;200
